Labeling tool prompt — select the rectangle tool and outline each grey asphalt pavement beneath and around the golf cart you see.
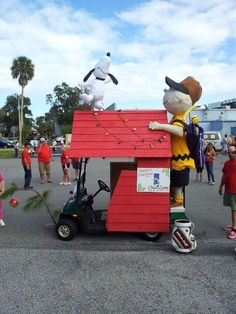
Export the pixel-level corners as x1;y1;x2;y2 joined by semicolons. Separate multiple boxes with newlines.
0;156;236;314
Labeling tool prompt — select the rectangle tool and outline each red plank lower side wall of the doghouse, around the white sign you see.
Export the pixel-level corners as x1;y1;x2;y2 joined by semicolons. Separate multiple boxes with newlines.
107;158;170;232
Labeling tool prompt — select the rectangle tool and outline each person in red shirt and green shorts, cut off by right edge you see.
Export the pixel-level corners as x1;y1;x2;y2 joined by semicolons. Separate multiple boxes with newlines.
219;146;236;239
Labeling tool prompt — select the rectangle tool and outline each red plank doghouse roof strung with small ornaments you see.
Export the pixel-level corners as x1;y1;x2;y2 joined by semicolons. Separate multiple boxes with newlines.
70;110;171;158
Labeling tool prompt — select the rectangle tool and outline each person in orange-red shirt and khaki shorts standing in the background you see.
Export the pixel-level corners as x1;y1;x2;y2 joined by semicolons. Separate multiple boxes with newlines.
37;137;53;184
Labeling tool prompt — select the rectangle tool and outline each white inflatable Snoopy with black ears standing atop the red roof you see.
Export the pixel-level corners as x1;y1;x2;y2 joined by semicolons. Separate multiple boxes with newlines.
79;52;118;110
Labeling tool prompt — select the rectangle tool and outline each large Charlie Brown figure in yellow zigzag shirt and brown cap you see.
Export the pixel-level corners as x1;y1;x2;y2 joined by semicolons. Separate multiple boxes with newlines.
149;76;202;207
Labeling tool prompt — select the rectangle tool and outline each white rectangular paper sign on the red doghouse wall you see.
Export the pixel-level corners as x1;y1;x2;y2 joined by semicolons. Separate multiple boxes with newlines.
137;168;170;192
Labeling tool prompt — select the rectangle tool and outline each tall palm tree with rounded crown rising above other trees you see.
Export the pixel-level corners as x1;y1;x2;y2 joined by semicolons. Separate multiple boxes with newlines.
11;56;34;146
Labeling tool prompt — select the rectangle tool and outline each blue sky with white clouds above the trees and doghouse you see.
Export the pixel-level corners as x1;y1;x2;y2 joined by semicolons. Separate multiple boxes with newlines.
0;0;236;118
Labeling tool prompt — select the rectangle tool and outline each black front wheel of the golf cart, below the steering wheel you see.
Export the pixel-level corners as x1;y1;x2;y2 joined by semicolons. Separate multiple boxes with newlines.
56;218;78;241
